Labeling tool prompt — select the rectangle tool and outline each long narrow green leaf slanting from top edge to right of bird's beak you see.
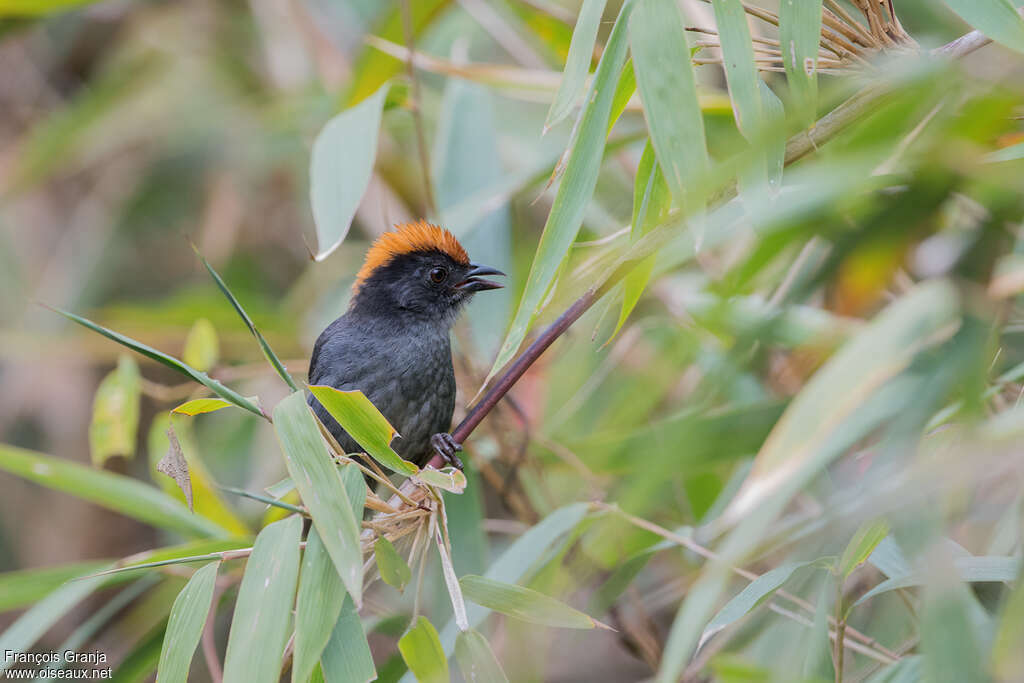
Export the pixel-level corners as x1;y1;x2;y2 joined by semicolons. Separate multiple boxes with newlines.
487;0;633;379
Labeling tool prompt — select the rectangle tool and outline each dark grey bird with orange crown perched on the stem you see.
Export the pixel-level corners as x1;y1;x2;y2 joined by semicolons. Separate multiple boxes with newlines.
306;220;505;469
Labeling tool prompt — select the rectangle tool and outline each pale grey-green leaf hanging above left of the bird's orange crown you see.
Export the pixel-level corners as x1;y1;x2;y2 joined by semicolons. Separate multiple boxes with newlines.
309;83;390;261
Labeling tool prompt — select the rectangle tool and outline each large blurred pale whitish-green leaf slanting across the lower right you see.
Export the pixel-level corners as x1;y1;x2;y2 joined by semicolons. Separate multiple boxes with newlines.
657;281;959;683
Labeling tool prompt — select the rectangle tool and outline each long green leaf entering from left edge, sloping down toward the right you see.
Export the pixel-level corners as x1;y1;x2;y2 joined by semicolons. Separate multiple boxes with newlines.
0;443;231;538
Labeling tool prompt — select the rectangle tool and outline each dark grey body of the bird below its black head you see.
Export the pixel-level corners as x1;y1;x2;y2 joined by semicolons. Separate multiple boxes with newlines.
307;312;456;465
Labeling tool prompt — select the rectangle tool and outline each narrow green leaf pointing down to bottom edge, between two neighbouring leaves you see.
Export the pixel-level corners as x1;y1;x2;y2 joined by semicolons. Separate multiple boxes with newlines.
292;528;345;683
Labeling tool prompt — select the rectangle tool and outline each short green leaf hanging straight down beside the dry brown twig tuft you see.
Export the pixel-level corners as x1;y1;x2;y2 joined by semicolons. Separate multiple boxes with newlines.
778;0;821;125
